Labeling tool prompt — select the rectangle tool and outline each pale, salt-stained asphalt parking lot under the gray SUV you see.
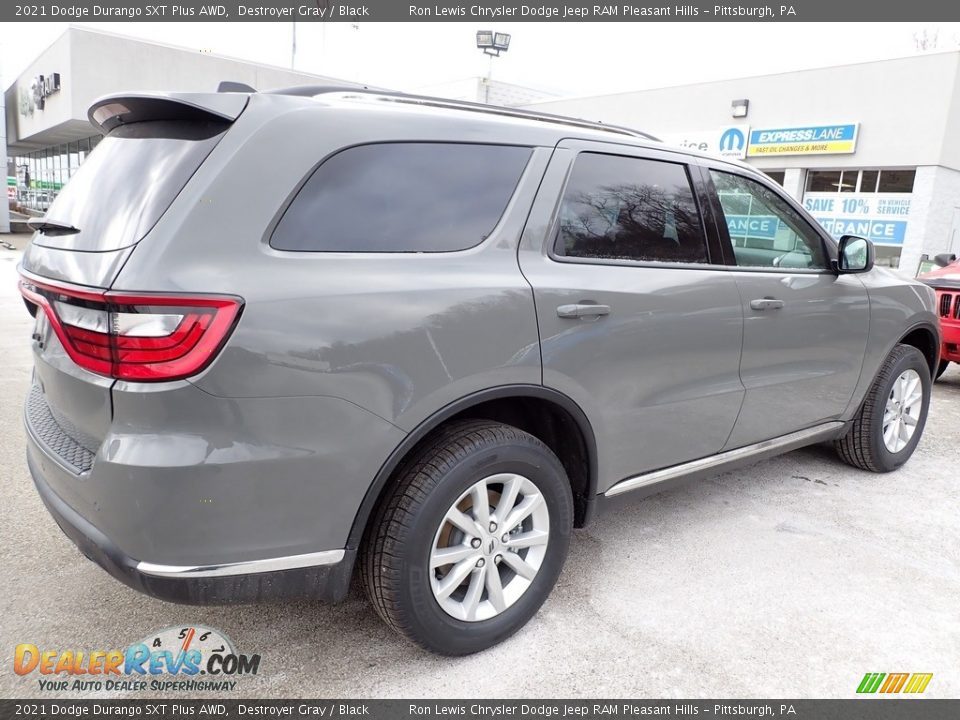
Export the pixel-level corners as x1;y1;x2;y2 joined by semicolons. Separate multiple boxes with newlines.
0;241;960;698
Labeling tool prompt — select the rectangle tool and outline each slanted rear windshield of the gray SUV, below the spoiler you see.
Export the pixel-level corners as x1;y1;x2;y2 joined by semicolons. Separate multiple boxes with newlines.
35;121;229;251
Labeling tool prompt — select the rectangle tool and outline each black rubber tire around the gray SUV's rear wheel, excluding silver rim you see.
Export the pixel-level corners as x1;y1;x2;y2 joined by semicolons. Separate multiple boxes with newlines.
360;420;573;655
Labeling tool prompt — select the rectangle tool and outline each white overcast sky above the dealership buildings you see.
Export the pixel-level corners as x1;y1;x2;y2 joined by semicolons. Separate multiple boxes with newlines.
0;22;960;95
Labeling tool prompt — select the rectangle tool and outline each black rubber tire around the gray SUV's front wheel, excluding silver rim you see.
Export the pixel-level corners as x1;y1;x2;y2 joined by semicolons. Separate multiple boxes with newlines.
833;345;931;473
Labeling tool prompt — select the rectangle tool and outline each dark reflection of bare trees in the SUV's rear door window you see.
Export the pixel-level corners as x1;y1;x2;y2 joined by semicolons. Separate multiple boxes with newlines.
560;181;707;262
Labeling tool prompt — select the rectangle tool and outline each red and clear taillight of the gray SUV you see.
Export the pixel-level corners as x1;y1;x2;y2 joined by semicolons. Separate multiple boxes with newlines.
20;277;243;382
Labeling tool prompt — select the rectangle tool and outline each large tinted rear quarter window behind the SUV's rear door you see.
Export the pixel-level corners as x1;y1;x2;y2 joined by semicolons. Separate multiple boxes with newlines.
270;143;531;252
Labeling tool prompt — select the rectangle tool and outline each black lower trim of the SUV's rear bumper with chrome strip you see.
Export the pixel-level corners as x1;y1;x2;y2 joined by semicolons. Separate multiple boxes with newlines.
27;452;355;605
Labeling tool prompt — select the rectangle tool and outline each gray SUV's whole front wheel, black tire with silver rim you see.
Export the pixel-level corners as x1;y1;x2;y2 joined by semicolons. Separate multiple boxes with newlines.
834;345;930;472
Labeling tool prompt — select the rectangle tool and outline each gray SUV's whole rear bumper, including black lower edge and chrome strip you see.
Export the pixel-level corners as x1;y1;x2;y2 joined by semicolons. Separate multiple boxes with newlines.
24;376;404;604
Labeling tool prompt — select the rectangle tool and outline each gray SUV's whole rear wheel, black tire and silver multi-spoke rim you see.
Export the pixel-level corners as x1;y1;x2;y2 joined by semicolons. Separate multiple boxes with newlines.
360;420;573;655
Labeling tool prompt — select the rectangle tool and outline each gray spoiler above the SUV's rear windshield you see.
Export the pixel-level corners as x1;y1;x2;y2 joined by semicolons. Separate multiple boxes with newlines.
87;93;249;133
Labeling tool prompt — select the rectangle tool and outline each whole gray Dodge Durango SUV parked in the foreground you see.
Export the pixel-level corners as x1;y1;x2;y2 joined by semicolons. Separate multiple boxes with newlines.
21;88;940;655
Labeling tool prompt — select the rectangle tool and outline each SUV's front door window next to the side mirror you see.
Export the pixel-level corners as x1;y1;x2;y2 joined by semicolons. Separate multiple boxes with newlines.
710;170;826;269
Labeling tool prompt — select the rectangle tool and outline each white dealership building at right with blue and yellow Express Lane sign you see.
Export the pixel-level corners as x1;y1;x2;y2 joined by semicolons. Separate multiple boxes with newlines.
525;51;960;274
